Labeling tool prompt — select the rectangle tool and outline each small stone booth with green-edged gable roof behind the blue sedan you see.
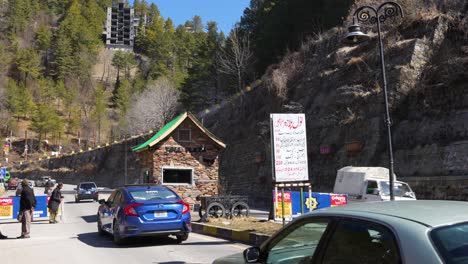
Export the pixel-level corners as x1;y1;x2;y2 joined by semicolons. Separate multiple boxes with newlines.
132;112;226;203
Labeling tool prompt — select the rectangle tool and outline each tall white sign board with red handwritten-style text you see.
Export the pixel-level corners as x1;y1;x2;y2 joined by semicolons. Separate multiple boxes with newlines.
270;114;309;182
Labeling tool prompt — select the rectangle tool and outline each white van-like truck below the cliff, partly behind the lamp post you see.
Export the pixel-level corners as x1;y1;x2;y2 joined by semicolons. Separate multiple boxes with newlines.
333;166;416;202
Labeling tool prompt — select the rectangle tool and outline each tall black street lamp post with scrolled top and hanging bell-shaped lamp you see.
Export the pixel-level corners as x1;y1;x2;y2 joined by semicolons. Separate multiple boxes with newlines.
343;2;403;201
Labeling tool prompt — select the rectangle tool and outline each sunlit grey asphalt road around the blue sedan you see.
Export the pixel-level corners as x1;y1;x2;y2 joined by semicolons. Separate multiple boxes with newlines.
0;185;248;264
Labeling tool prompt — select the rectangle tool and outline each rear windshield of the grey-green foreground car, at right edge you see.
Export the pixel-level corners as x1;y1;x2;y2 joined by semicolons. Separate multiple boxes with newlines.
431;223;468;264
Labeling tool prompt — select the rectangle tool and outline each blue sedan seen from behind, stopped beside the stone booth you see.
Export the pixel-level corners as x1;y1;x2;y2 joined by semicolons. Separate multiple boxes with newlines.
97;185;192;244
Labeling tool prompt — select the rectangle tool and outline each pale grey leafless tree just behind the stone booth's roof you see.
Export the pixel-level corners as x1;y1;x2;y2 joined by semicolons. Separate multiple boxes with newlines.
127;78;180;133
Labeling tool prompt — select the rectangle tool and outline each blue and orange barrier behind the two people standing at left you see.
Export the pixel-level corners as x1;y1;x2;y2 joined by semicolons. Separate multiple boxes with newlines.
0;195;58;221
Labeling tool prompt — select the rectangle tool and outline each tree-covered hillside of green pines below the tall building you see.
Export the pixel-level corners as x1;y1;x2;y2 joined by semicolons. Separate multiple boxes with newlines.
0;0;350;165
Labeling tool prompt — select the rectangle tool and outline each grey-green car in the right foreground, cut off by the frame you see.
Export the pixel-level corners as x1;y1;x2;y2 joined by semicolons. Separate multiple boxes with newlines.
213;200;468;264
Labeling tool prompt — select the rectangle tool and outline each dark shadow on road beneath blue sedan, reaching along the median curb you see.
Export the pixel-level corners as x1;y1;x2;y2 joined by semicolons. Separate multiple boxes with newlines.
78;232;238;249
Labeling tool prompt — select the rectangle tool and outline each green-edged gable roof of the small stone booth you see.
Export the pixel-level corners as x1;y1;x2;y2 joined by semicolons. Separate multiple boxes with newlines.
132;112;226;151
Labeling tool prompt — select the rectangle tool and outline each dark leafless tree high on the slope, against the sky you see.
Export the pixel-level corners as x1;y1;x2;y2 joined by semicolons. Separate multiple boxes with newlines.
217;27;253;95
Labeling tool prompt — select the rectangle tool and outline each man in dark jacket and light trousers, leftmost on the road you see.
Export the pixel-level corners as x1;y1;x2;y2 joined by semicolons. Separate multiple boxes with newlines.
17;179;37;238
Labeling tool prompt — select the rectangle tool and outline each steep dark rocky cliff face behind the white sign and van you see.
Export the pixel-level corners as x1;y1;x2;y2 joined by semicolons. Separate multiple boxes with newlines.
199;16;468;205
